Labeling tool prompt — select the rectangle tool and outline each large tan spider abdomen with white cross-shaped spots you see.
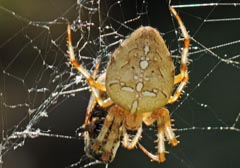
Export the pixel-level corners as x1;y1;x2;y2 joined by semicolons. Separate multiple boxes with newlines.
106;26;174;113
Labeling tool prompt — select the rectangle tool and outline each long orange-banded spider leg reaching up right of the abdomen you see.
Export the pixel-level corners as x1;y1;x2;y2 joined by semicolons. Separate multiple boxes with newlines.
168;6;190;103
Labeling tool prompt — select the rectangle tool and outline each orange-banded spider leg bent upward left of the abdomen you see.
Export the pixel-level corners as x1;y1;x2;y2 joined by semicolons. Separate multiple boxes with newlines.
67;25;113;107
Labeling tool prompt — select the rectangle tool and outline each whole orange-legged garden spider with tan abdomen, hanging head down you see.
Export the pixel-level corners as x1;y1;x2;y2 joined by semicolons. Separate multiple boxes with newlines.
67;6;190;163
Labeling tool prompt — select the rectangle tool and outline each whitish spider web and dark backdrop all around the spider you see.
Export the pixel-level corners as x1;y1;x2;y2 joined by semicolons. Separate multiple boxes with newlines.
0;0;240;168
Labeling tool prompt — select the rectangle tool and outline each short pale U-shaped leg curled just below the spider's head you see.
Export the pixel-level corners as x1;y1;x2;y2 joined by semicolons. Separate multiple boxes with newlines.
122;126;142;150
